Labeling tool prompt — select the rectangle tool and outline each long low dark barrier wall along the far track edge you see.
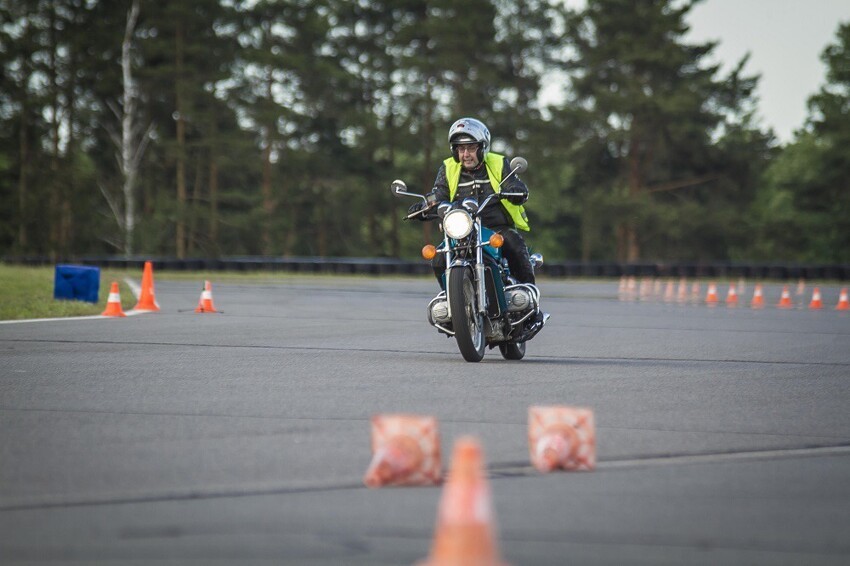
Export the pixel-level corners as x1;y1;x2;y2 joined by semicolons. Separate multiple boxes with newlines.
2;256;850;281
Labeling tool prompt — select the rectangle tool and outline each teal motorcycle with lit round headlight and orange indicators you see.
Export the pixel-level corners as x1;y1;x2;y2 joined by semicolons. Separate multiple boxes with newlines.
391;157;549;362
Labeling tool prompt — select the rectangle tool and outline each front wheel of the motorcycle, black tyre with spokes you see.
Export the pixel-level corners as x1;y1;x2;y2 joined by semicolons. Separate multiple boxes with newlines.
449;267;486;362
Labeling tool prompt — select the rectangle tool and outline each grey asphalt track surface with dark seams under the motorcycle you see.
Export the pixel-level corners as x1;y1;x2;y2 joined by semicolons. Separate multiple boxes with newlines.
0;278;850;566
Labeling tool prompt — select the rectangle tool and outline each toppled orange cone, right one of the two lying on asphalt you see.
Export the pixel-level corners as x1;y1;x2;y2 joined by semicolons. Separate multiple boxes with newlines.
528;406;596;473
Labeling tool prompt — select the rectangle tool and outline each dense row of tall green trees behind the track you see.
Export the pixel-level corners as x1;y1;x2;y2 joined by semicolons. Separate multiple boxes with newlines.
0;0;850;262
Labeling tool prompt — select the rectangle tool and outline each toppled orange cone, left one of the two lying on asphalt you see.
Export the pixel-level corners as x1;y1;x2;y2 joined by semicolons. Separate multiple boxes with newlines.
363;415;441;487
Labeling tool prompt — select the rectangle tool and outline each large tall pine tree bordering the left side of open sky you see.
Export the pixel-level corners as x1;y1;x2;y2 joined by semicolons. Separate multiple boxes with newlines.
567;0;755;261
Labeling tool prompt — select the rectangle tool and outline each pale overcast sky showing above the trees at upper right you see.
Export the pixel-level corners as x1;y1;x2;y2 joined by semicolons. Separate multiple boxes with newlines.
552;0;850;143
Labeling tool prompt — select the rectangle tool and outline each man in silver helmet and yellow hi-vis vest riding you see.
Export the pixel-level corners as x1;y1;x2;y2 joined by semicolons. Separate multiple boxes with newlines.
408;118;548;337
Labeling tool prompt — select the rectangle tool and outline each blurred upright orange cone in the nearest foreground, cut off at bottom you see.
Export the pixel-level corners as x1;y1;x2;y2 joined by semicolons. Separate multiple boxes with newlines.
418;437;505;566
